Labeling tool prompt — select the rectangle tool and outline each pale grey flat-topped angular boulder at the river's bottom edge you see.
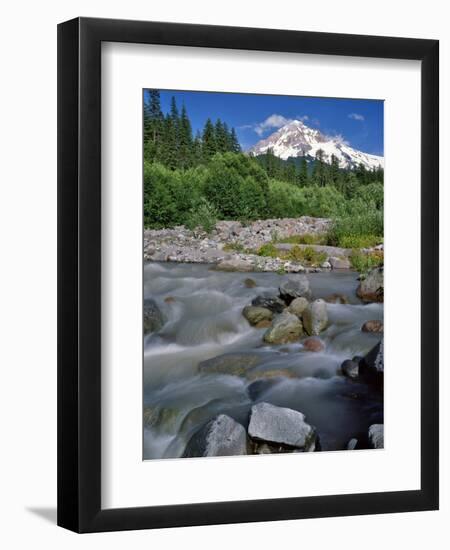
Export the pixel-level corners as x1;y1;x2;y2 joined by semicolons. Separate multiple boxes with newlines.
248;402;317;452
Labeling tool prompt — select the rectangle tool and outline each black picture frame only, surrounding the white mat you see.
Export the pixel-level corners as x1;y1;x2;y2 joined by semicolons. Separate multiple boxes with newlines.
58;18;439;532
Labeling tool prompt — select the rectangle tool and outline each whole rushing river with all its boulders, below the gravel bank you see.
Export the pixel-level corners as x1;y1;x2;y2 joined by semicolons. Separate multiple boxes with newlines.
144;262;384;459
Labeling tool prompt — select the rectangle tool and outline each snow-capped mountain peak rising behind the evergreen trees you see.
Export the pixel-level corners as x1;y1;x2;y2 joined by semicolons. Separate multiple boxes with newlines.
248;120;384;170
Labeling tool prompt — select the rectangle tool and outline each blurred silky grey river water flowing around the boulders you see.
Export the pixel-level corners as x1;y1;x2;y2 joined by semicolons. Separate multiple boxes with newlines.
144;262;383;459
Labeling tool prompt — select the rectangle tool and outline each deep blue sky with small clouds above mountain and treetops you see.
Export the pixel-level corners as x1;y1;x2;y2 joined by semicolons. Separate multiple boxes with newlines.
154;91;384;155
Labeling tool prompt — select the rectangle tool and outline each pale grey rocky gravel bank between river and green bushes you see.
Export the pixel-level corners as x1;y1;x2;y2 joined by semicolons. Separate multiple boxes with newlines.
144;217;383;273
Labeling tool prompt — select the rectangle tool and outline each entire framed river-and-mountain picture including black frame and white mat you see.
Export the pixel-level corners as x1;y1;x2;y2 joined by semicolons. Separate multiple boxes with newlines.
58;18;439;532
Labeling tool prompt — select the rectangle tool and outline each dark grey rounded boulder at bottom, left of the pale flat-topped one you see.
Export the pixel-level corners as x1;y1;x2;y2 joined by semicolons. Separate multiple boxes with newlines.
183;414;247;458
